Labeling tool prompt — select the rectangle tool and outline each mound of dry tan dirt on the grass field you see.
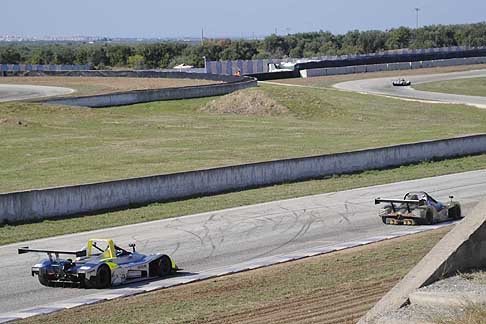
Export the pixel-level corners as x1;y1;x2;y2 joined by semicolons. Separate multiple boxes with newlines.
201;89;289;116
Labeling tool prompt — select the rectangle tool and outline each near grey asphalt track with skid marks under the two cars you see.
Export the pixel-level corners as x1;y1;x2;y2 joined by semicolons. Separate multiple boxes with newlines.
0;170;486;313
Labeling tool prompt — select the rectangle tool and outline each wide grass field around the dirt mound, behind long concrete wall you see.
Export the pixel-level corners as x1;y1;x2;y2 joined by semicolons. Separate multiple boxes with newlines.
0;69;486;192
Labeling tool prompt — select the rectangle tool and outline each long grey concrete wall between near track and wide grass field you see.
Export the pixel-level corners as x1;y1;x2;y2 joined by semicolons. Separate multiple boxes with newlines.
0;134;486;223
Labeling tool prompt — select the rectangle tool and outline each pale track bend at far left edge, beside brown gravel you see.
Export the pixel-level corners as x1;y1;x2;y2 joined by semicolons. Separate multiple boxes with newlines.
0;84;74;102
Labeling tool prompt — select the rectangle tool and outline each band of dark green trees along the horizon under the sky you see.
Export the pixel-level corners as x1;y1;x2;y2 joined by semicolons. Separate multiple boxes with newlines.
0;23;486;69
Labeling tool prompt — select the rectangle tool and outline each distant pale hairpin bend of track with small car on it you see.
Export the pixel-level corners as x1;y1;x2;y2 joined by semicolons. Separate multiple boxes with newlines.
334;70;486;108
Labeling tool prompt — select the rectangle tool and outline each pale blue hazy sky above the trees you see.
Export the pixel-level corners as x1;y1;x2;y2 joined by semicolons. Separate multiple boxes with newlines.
0;0;486;37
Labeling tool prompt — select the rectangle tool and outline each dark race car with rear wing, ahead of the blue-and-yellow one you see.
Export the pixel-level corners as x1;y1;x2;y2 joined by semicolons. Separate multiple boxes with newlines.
375;191;461;225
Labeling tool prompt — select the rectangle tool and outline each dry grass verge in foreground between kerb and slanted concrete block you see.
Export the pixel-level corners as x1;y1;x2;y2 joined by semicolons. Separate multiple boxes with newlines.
19;228;448;324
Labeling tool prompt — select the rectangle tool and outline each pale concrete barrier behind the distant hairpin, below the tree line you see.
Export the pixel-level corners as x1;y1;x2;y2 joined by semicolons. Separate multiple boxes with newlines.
300;57;486;78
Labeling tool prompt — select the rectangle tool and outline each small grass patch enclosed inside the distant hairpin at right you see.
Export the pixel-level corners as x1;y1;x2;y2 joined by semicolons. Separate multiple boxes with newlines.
413;78;486;97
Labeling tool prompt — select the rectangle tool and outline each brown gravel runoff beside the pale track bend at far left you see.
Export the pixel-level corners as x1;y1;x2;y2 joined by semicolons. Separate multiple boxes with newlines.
0;76;221;95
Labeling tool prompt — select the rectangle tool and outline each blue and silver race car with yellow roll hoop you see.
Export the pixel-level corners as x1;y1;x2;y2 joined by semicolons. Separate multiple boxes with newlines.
18;239;180;289
